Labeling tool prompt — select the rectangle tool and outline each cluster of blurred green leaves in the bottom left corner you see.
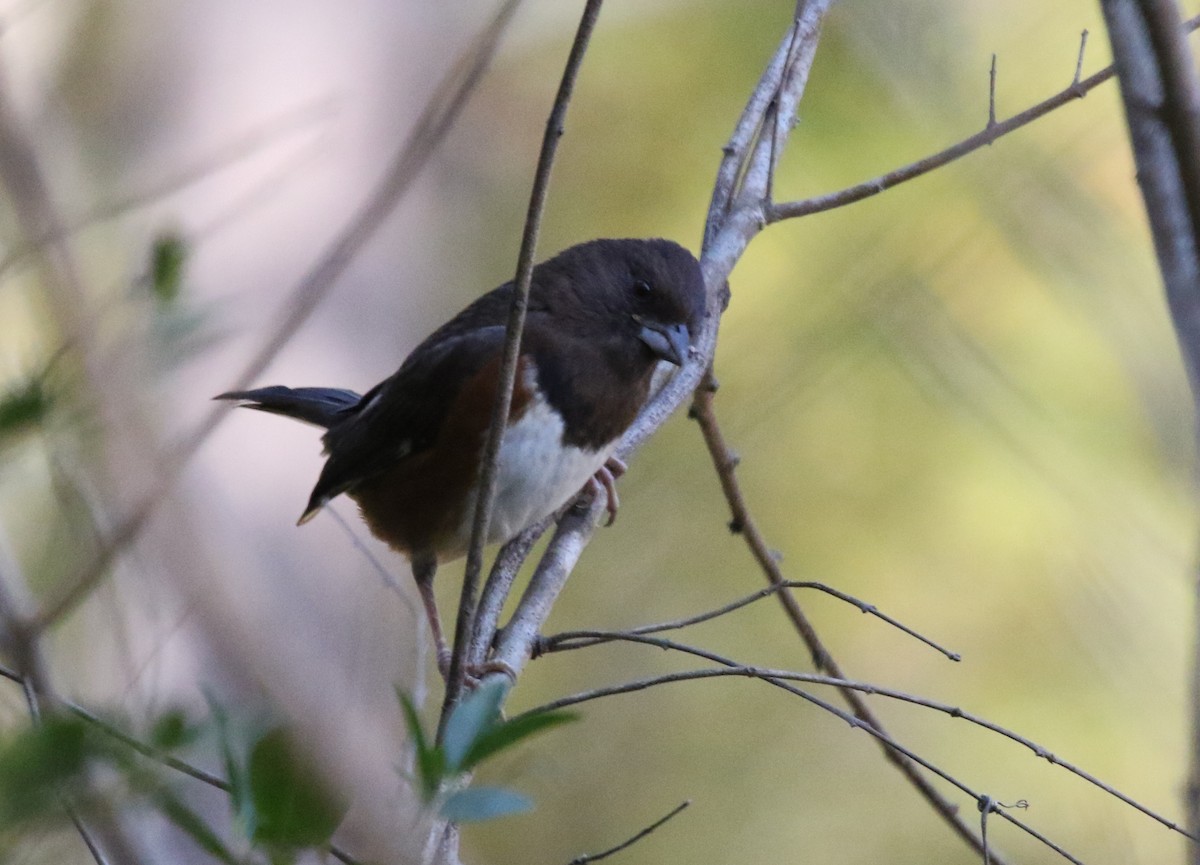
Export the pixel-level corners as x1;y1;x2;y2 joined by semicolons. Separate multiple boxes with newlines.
0;704;346;865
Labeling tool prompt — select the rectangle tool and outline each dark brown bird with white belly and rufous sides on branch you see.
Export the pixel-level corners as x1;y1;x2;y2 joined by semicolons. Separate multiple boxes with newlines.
214;238;706;677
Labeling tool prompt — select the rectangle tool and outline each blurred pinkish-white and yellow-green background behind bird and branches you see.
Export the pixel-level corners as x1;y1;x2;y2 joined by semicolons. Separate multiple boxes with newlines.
0;0;1200;865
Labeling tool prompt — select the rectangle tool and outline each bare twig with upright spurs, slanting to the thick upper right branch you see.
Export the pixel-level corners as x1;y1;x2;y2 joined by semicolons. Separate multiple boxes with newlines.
766;16;1200;223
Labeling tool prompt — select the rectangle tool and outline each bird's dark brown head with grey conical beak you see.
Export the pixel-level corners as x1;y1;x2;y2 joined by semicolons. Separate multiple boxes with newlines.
529;240;704;366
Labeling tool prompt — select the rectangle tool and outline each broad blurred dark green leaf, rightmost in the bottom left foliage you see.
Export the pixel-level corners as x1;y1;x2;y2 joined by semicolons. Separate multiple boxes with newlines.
247;727;347;847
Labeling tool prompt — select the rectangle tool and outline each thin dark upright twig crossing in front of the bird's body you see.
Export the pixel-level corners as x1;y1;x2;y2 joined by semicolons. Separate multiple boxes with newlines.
439;0;604;719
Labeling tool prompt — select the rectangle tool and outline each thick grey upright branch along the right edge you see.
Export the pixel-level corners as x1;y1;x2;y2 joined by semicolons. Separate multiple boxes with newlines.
1100;0;1200;849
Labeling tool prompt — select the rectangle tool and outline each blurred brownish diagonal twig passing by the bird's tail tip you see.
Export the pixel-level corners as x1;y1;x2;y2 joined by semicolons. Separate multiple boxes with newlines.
27;0;521;629
